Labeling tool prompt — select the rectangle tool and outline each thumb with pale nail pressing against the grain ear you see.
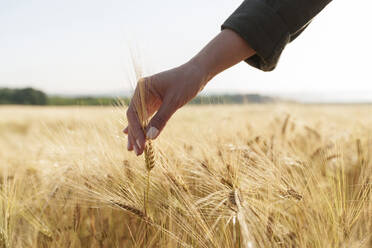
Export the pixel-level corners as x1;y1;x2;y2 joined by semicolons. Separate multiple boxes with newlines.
146;101;176;139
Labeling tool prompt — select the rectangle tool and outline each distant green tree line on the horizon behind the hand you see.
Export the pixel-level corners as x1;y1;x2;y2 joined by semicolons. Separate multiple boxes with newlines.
0;88;275;106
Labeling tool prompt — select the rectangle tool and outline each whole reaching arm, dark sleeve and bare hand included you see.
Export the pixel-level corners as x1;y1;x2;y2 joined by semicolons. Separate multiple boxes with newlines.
124;0;331;155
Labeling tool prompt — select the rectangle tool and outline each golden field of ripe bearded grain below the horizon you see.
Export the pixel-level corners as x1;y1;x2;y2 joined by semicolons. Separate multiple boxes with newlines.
0;105;372;248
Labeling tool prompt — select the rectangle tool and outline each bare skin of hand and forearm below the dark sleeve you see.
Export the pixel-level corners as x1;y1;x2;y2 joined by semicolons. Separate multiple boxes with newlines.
124;29;255;156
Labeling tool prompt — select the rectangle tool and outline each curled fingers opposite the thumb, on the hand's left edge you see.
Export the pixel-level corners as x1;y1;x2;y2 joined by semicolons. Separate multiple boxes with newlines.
124;106;146;156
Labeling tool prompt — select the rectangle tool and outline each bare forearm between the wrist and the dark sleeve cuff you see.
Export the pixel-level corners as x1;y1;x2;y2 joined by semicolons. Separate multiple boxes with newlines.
188;29;255;86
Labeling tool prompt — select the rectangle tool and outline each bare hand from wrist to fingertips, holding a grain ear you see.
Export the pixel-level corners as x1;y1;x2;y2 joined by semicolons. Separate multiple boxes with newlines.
124;62;206;155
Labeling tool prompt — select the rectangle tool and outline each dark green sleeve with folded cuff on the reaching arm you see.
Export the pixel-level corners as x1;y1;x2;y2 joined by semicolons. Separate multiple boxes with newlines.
222;0;331;71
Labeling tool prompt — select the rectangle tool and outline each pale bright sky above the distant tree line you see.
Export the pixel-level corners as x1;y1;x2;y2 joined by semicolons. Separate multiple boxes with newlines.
0;0;372;102
